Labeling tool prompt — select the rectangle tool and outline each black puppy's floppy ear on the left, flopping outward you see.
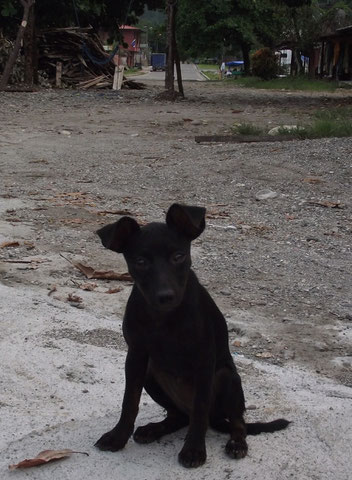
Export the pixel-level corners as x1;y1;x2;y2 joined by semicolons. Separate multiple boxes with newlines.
97;217;140;253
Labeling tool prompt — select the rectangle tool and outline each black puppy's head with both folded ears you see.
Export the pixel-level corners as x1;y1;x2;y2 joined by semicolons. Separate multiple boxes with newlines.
97;203;205;312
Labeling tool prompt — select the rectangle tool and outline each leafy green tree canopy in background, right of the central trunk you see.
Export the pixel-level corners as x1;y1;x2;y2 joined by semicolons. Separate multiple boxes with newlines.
178;0;281;73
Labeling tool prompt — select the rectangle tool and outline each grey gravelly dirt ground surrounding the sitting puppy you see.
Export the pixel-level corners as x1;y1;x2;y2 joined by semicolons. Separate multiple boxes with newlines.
0;82;352;480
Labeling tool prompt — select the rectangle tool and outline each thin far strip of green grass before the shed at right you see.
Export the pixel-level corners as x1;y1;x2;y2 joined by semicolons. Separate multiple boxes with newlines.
234;76;338;92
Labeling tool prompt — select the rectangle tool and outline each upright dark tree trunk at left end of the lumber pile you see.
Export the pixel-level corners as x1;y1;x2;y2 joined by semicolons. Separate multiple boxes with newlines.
23;4;38;85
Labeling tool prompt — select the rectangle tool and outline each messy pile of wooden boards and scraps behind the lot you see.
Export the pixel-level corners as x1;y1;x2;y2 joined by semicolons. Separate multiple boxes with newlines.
38;27;143;90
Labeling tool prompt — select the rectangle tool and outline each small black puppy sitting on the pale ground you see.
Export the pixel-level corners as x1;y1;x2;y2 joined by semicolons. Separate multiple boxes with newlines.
96;204;289;467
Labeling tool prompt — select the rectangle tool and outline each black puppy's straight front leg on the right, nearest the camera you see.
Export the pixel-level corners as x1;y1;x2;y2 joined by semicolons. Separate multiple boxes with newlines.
178;366;214;468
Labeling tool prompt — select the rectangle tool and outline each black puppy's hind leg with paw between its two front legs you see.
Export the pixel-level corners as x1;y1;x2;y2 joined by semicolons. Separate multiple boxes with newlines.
133;374;189;443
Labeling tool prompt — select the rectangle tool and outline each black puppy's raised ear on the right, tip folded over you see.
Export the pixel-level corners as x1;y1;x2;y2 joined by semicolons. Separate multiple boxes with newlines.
166;203;206;240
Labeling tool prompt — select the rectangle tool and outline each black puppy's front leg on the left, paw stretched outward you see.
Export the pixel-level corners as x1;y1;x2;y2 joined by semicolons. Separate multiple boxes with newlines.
95;348;148;452
